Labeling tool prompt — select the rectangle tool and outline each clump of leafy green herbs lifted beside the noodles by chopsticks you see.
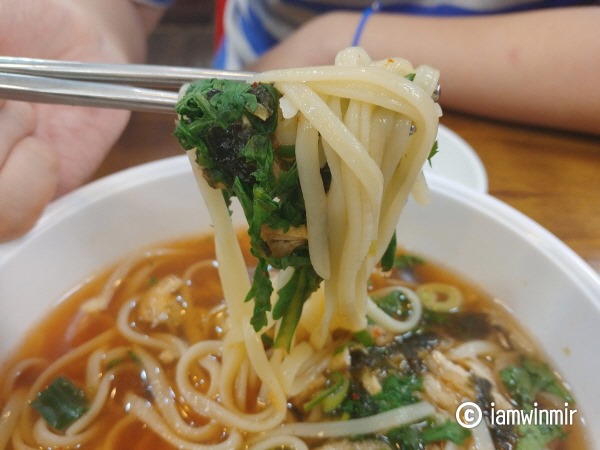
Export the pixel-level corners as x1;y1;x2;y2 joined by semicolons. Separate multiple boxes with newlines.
174;79;322;349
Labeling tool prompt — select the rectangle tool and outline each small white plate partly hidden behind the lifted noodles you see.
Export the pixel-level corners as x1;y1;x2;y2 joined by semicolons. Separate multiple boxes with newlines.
424;125;488;192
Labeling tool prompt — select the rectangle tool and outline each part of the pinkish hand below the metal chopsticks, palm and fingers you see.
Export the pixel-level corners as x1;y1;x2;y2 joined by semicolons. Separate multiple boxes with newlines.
0;102;129;242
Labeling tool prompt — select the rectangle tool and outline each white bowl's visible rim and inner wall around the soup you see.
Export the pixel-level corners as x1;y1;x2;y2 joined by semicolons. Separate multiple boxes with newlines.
0;156;600;443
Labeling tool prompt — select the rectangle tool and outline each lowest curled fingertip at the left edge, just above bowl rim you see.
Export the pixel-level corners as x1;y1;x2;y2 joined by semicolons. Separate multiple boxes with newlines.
0;136;59;242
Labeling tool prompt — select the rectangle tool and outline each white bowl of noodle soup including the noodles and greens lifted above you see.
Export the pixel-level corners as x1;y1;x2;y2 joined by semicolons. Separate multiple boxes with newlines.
0;48;600;450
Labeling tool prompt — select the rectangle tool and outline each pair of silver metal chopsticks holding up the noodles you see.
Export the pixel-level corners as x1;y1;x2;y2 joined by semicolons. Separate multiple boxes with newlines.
0;57;253;114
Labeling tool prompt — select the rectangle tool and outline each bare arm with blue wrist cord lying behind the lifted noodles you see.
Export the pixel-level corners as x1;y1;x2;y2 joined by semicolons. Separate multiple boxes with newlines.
247;6;600;134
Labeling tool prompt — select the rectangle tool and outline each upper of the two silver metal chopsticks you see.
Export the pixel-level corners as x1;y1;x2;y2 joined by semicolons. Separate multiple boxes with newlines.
0;56;254;88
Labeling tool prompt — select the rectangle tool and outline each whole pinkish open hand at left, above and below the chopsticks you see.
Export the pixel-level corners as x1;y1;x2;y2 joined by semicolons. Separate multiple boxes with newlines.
0;0;157;242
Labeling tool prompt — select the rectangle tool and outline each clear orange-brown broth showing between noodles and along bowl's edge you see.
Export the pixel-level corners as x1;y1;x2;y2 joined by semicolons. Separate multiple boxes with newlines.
0;237;589;450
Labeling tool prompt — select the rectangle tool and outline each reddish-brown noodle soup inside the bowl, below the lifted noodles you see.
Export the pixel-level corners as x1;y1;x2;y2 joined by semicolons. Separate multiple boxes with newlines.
2;236;586;449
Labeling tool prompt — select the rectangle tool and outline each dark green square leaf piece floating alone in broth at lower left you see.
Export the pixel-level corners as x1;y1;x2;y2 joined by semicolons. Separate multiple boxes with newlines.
31;376;88;431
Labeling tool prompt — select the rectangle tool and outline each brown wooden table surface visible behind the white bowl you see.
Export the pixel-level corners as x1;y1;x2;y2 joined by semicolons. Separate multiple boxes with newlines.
96;112;600;273
